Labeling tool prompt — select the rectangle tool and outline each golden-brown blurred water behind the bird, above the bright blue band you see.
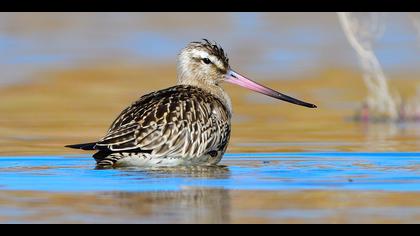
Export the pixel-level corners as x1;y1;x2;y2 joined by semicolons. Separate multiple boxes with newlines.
0;64;420;156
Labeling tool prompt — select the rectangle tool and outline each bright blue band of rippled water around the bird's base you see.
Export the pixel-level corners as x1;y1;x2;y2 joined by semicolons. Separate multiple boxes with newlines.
0;152;420;192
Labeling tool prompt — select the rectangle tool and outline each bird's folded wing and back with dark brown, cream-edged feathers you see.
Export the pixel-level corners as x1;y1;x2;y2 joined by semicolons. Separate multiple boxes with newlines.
96;86;230;157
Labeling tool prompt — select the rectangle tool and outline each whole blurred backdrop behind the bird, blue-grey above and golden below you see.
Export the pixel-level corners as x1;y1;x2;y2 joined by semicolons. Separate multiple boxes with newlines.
0;12;420;155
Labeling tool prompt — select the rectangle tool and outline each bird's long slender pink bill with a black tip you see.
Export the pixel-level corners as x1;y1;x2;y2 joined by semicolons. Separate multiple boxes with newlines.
226;70;317;108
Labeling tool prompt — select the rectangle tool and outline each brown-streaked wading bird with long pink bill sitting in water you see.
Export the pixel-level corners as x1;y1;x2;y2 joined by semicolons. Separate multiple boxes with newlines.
65;39;317;168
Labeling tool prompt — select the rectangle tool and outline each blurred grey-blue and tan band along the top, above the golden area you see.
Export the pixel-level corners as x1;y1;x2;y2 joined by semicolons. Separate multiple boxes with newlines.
0;12;420;84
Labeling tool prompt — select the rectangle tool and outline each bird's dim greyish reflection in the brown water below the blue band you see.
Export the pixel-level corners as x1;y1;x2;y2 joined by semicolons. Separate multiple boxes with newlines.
104;187;230;223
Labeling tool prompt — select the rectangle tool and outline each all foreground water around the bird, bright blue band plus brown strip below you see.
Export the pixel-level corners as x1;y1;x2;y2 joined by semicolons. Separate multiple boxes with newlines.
0;152;420;223
